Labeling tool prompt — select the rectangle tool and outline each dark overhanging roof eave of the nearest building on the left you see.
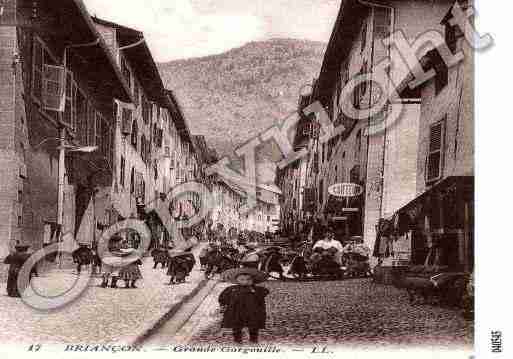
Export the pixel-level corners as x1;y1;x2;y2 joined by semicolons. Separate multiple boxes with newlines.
47;0;132;102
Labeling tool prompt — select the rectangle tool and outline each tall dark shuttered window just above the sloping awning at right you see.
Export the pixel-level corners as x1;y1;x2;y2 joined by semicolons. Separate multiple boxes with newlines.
426;119;445;183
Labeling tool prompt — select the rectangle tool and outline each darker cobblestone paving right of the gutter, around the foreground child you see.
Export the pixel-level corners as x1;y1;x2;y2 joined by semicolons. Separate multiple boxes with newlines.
186;279;473;348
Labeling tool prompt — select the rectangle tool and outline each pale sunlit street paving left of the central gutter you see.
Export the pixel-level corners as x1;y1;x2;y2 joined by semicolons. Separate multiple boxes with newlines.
0;248;204;346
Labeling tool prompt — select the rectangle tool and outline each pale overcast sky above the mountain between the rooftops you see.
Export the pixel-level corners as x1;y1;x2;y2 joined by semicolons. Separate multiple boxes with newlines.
84;0;341;61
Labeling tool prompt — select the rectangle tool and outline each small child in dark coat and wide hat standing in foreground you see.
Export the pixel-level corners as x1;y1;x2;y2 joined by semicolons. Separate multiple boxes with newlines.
219;268;269;344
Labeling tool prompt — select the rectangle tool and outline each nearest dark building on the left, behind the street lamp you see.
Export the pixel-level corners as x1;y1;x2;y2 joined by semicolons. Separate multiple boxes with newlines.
0;0;131;256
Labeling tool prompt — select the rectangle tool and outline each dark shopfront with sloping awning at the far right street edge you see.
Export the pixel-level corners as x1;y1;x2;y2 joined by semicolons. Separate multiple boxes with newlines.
373;176;474;282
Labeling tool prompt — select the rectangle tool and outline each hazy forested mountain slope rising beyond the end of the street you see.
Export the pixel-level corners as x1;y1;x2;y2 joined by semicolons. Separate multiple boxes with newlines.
159;39;325;158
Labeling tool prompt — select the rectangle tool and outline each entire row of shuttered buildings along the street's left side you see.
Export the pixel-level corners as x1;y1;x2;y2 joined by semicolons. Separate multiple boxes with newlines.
0;0;202;257
